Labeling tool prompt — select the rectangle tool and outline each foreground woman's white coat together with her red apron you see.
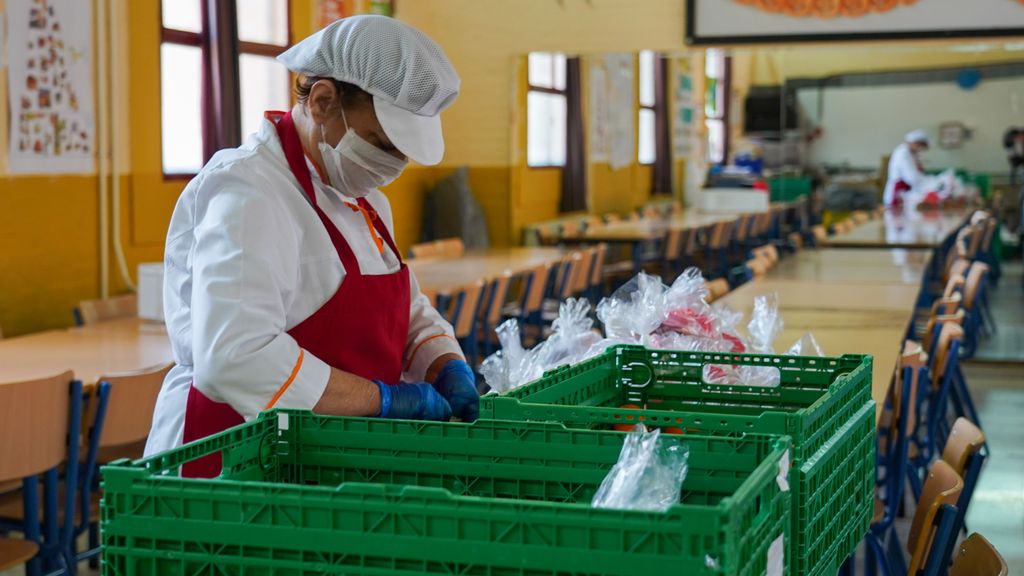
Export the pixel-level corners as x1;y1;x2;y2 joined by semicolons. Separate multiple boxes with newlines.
145;114;461;467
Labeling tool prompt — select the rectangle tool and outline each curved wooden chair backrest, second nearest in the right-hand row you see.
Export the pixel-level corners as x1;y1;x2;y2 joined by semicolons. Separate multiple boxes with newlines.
906;460;964;574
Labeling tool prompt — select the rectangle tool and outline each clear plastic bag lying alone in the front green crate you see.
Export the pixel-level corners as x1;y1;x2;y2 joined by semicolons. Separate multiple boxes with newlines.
591;424;689;512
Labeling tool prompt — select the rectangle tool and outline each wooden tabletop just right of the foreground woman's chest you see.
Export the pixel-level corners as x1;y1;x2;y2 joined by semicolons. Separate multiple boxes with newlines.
409;247;566;294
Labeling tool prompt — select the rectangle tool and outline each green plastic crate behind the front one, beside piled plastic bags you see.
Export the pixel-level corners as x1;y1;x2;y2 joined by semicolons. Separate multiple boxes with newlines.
480;346;874;574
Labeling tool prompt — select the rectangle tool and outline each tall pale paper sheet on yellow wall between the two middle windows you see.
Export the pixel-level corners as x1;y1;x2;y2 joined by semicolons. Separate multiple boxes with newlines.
604;54;636;170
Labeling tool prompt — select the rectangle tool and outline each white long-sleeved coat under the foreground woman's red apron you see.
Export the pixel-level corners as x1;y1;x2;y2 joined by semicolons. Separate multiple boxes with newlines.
145;120;461;455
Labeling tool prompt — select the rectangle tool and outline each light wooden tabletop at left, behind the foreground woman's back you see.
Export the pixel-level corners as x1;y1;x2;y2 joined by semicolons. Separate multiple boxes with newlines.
0;318;173;382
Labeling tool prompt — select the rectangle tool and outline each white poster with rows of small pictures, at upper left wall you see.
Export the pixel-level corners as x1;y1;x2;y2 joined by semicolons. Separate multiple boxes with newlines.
7;0;95;174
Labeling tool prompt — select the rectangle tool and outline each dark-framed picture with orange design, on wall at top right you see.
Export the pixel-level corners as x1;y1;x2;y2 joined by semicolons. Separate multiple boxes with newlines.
686;0;1024;46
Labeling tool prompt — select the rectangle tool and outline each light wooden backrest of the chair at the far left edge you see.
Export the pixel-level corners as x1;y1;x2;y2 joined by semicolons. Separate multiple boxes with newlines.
0;371;77;483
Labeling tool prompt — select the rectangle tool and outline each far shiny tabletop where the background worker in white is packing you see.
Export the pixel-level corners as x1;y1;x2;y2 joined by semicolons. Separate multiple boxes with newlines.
828;208;973;249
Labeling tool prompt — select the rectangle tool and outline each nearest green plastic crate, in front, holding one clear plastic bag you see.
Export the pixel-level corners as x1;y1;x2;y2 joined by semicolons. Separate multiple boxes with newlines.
101;411;792;576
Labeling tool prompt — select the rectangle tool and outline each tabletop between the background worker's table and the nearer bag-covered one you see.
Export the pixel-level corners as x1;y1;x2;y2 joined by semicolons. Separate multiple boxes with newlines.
770;248;931;285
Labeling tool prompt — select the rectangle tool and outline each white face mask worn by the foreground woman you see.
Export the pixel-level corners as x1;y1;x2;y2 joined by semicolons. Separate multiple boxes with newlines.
318;109;409;198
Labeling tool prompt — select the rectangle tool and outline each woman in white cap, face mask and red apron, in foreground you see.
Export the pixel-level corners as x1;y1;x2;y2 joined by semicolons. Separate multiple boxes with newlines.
145;15;479;478
